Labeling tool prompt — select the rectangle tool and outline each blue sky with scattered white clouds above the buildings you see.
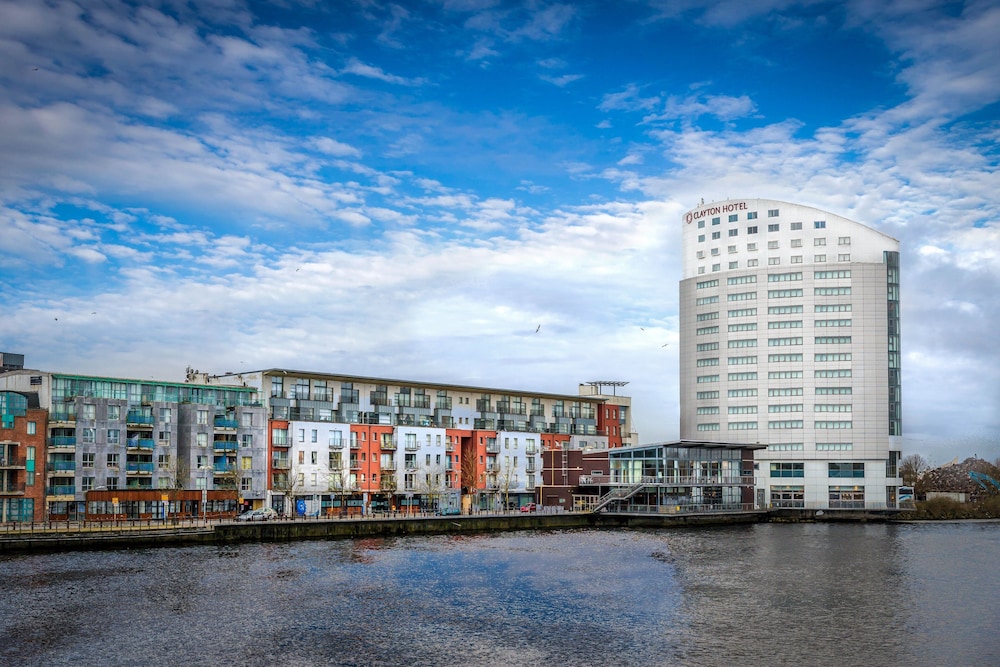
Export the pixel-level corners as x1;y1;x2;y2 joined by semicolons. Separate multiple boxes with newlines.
0;0;1000;464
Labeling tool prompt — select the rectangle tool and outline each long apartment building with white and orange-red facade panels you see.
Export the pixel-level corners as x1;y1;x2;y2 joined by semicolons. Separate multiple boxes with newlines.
211;369;637;515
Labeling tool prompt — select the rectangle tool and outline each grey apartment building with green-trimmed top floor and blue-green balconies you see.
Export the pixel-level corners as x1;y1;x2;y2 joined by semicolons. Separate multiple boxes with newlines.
0;368;267;519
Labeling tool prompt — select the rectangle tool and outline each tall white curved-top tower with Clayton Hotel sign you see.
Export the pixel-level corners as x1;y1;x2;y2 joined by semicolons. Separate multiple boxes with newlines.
680;199;902;510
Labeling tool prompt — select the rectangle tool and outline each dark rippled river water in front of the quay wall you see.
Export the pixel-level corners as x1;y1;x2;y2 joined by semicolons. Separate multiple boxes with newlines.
0;522;1000;667
